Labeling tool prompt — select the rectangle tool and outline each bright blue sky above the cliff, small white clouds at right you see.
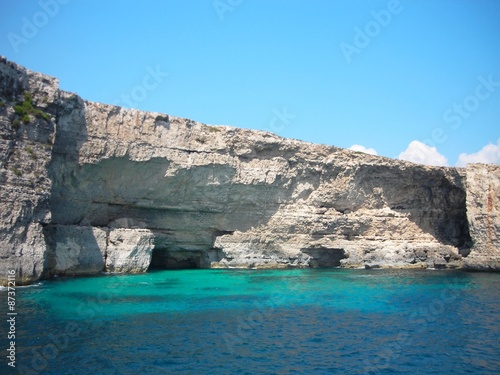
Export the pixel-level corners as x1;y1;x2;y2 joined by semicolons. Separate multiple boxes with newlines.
0;0;500;165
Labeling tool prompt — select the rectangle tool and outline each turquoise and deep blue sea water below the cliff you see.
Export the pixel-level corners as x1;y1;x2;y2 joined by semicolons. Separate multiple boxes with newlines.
0;269;500;375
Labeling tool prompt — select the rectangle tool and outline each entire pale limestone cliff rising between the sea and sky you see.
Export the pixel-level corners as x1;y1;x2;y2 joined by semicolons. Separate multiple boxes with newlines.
0;59;500;283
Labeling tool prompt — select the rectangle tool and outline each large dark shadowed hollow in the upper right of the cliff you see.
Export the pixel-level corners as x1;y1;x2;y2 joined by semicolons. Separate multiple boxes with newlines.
352;165;470;248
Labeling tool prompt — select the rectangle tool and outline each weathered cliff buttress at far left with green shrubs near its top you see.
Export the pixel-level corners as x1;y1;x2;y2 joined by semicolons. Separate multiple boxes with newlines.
0;57;59;284
